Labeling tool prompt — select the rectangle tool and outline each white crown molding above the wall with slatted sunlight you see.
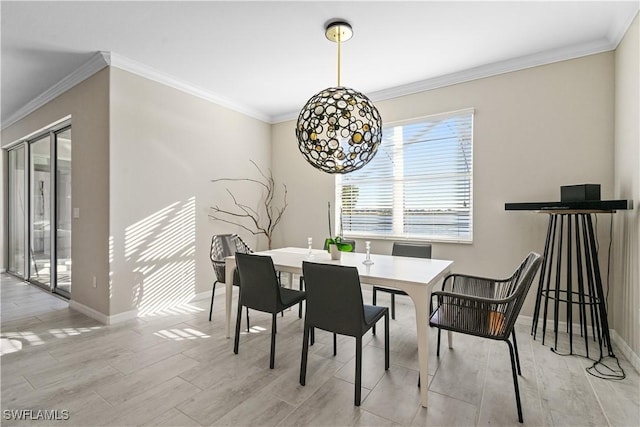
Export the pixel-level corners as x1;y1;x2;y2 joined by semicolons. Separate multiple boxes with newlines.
110;52;270;123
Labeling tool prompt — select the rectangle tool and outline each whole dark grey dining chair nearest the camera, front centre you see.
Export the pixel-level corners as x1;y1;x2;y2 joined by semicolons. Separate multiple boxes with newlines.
300;261;389;406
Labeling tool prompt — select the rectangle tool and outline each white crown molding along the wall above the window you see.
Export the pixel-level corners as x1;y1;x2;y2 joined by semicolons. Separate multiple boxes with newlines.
271;39;617;123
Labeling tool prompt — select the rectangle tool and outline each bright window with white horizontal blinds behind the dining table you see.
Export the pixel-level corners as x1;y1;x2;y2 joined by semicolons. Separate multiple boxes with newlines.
336;109;473;242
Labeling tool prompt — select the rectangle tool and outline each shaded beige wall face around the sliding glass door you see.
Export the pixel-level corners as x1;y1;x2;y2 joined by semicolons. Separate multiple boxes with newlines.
2;68;109;314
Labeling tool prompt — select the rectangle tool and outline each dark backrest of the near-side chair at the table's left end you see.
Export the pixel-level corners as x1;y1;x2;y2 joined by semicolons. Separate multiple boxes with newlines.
236;252;282;313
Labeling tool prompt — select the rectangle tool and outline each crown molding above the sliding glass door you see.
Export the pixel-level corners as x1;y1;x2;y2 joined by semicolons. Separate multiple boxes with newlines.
1;52;109;129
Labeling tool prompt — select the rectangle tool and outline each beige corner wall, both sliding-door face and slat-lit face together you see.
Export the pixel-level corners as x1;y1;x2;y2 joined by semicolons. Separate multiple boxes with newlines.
2;68;271;321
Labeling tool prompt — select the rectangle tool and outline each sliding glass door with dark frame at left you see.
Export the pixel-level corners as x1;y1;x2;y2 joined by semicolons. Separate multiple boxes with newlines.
8;124;72;297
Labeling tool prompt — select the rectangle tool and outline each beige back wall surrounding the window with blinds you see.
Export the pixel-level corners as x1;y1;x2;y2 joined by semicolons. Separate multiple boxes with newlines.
272;52;614;316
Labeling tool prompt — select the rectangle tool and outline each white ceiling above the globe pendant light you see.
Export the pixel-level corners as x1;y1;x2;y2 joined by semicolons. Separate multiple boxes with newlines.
0;0;640;127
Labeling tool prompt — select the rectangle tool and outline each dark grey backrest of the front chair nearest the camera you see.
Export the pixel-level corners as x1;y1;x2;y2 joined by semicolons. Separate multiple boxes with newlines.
302;261;364;336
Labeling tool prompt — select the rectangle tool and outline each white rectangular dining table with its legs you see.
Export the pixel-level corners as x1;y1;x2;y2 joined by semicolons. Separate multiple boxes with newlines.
225;247;453;408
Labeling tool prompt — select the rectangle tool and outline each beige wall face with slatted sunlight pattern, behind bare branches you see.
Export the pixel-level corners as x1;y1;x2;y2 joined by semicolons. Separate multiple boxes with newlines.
109;68;271;316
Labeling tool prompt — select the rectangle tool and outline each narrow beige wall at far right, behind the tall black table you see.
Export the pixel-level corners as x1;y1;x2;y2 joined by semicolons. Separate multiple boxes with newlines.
612;15;640;369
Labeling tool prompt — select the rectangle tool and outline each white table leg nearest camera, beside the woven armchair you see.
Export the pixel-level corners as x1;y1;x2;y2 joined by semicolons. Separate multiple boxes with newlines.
407;286;429;408
